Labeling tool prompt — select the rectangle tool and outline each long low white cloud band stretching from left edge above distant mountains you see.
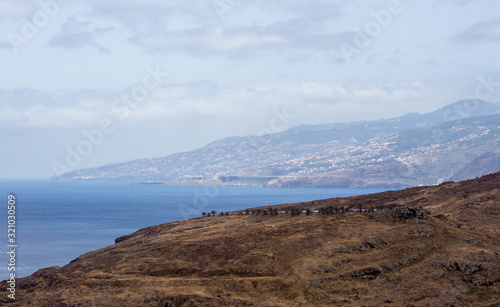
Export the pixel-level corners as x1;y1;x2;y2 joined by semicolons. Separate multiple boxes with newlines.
0;82;442;128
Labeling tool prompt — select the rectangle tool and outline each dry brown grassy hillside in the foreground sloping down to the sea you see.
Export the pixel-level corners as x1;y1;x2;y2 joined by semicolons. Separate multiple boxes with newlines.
0;173;500;306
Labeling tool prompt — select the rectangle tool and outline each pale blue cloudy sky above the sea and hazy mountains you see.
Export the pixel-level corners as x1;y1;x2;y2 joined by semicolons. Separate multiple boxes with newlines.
0;0;500;178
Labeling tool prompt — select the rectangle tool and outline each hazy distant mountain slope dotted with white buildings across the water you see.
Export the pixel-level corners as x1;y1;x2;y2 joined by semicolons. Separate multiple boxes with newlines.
55;100;500;187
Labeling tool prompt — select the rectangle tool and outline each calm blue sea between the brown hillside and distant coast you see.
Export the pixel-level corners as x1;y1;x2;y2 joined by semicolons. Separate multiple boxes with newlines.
0;180;388;280
